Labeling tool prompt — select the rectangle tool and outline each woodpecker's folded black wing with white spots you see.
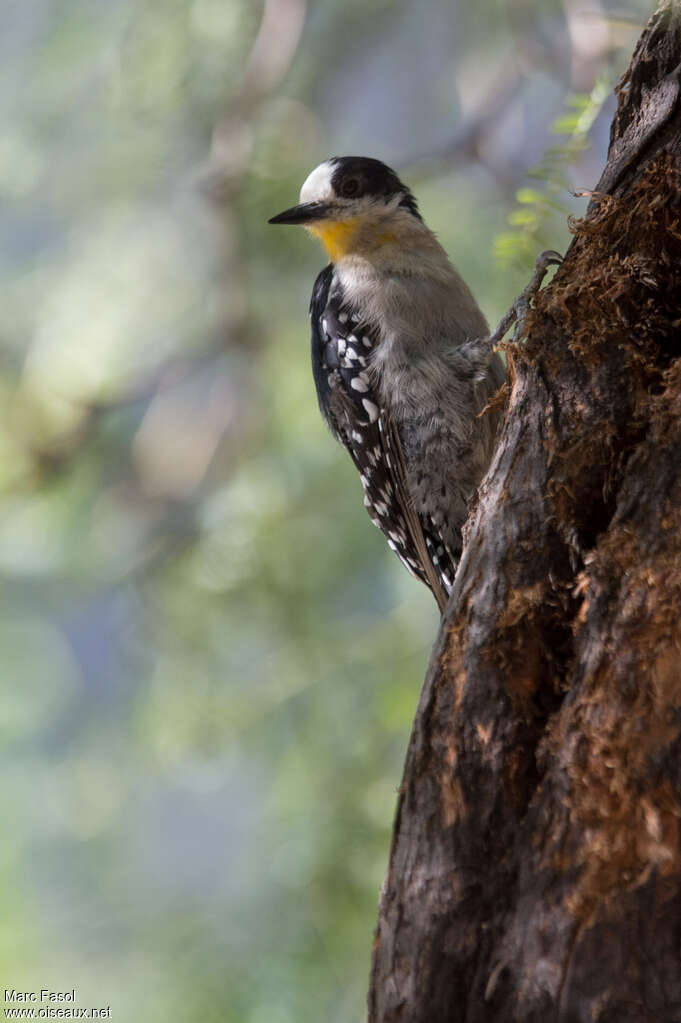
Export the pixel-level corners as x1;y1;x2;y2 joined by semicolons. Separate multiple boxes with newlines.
310;265;455;610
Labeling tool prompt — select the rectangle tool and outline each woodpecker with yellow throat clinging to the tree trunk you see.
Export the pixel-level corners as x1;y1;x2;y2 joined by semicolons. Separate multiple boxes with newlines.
269;157;504;611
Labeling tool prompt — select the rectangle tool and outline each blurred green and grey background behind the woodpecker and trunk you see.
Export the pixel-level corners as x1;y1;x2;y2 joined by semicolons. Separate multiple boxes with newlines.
0;0;648;1023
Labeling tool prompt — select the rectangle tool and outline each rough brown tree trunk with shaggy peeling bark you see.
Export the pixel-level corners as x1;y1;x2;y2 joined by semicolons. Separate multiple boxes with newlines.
369;2;681;1023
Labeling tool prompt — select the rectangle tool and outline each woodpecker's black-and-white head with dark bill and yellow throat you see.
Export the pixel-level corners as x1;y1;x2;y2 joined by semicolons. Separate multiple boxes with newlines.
269;157;421;262
